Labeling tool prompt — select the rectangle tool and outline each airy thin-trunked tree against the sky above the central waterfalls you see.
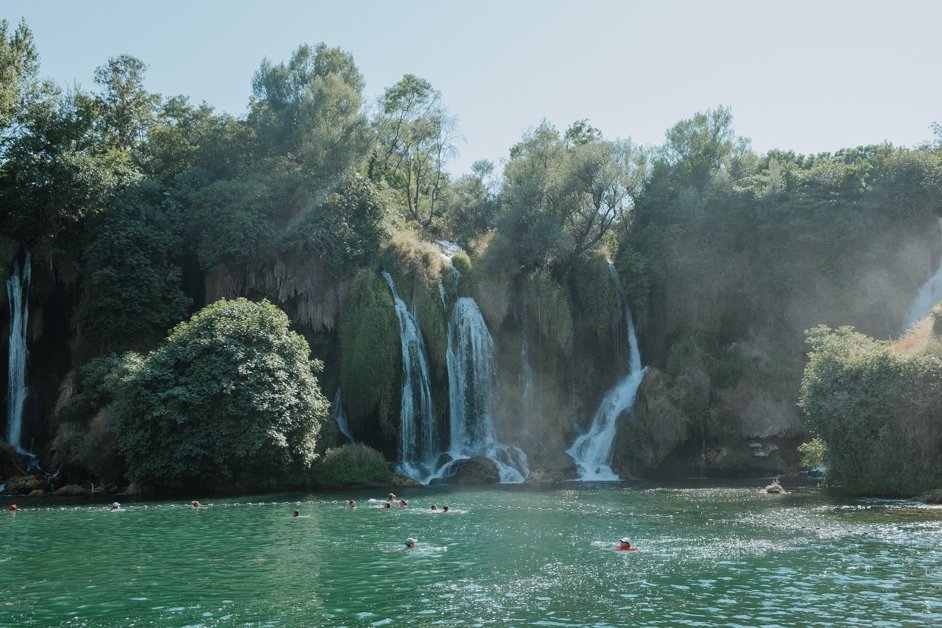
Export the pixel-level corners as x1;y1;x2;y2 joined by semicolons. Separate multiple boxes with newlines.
370;74;456;227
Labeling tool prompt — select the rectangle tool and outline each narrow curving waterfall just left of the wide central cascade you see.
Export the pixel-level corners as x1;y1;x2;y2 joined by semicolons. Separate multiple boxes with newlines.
383;271;438;478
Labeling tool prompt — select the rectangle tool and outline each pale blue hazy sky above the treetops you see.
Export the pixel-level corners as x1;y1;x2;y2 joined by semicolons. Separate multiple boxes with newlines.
0;0;942;173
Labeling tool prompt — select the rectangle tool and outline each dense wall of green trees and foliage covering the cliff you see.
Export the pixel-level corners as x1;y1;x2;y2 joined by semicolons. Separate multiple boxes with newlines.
0;21;942;493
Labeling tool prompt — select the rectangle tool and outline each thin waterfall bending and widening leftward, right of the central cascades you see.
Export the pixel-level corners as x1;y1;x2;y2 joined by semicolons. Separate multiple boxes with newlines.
566;264;647;482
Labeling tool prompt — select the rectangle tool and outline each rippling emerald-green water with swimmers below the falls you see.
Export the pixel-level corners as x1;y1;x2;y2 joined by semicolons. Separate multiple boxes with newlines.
0;484;942;626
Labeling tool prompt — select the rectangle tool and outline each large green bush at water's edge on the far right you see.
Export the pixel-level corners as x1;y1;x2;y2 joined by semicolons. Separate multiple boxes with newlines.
801;326;942;496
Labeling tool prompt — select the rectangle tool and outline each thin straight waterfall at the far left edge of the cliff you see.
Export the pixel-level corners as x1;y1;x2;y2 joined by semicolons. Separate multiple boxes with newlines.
7;250;32;455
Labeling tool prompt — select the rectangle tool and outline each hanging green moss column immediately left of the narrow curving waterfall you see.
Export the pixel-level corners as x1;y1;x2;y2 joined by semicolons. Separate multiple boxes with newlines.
340;269;401;438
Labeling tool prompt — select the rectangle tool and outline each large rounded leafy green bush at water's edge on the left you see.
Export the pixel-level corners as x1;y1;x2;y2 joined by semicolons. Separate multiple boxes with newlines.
112;298;329;490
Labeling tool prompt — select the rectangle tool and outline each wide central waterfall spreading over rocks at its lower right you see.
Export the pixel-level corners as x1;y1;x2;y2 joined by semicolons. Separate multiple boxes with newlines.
447;297;530;482
